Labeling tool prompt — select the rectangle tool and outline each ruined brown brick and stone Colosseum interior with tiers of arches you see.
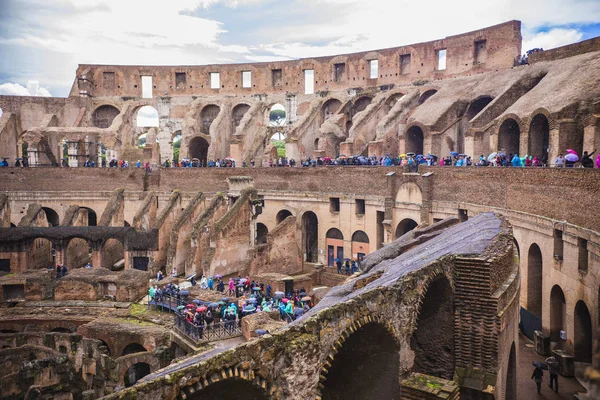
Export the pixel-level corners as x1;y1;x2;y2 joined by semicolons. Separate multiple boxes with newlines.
0;21;600;400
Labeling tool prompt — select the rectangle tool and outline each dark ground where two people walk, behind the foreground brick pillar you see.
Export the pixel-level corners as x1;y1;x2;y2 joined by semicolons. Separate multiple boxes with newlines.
507;334;585;400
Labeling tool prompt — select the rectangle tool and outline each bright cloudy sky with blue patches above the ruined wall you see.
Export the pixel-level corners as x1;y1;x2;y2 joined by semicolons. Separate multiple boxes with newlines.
0;0;600;96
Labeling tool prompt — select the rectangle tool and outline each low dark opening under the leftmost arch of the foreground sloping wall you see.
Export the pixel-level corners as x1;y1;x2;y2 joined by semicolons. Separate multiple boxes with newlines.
182;376;273;400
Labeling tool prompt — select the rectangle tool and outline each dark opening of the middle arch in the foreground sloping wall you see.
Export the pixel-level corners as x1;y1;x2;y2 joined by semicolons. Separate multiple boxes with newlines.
322;322;400;400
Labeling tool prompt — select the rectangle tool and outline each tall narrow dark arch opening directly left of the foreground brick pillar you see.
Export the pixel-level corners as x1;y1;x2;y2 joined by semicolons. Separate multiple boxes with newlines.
410;275;454;380
